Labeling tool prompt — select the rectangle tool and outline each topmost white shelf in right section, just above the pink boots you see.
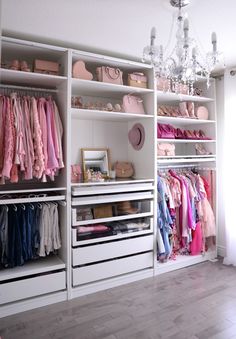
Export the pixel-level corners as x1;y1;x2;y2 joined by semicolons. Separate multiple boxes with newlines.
156;91;214;103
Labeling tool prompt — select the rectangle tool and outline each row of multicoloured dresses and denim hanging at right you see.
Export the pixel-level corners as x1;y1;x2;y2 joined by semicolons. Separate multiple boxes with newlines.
157;170;216;262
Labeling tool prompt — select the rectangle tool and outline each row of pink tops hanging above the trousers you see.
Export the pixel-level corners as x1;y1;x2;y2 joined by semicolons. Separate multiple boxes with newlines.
0;93;64;184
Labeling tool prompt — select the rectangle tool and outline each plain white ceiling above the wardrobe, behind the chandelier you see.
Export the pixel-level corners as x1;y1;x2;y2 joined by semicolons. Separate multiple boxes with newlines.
2;0;236;66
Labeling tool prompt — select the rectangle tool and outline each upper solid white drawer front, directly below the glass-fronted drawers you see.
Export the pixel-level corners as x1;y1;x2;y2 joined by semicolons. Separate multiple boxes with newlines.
72;235;153;266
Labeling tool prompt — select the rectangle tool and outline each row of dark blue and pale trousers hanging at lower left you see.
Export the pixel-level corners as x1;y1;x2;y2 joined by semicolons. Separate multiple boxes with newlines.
0;202;61;268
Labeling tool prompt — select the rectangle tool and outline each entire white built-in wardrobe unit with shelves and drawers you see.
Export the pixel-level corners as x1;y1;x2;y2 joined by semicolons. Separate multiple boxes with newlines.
0;37;217;316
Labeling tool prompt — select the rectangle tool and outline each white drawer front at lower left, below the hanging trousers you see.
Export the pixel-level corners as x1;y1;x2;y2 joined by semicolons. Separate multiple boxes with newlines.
0;272;66;304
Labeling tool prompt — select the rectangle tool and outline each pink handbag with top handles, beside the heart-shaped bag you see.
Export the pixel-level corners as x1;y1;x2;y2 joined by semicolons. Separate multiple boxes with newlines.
96;66;123;85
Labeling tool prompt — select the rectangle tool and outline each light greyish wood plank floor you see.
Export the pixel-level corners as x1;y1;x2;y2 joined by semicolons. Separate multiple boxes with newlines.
0;262;236;339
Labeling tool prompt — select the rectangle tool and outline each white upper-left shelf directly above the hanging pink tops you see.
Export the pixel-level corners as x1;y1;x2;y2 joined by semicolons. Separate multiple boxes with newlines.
0;68;67;91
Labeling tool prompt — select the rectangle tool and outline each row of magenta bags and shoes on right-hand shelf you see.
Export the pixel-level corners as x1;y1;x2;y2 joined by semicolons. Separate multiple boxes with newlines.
157;124;211;140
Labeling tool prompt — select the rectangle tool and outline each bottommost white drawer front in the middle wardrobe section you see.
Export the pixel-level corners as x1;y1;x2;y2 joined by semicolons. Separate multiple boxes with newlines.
73;252;153;286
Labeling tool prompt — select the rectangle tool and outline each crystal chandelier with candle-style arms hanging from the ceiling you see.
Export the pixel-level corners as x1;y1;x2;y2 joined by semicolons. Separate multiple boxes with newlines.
143;0;223;94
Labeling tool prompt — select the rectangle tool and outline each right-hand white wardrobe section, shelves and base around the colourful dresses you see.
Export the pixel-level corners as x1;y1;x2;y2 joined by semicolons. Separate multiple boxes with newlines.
154;79;217;275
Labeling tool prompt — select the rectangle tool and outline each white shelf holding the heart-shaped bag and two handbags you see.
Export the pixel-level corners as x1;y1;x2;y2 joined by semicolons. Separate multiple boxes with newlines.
72;78;153;97
